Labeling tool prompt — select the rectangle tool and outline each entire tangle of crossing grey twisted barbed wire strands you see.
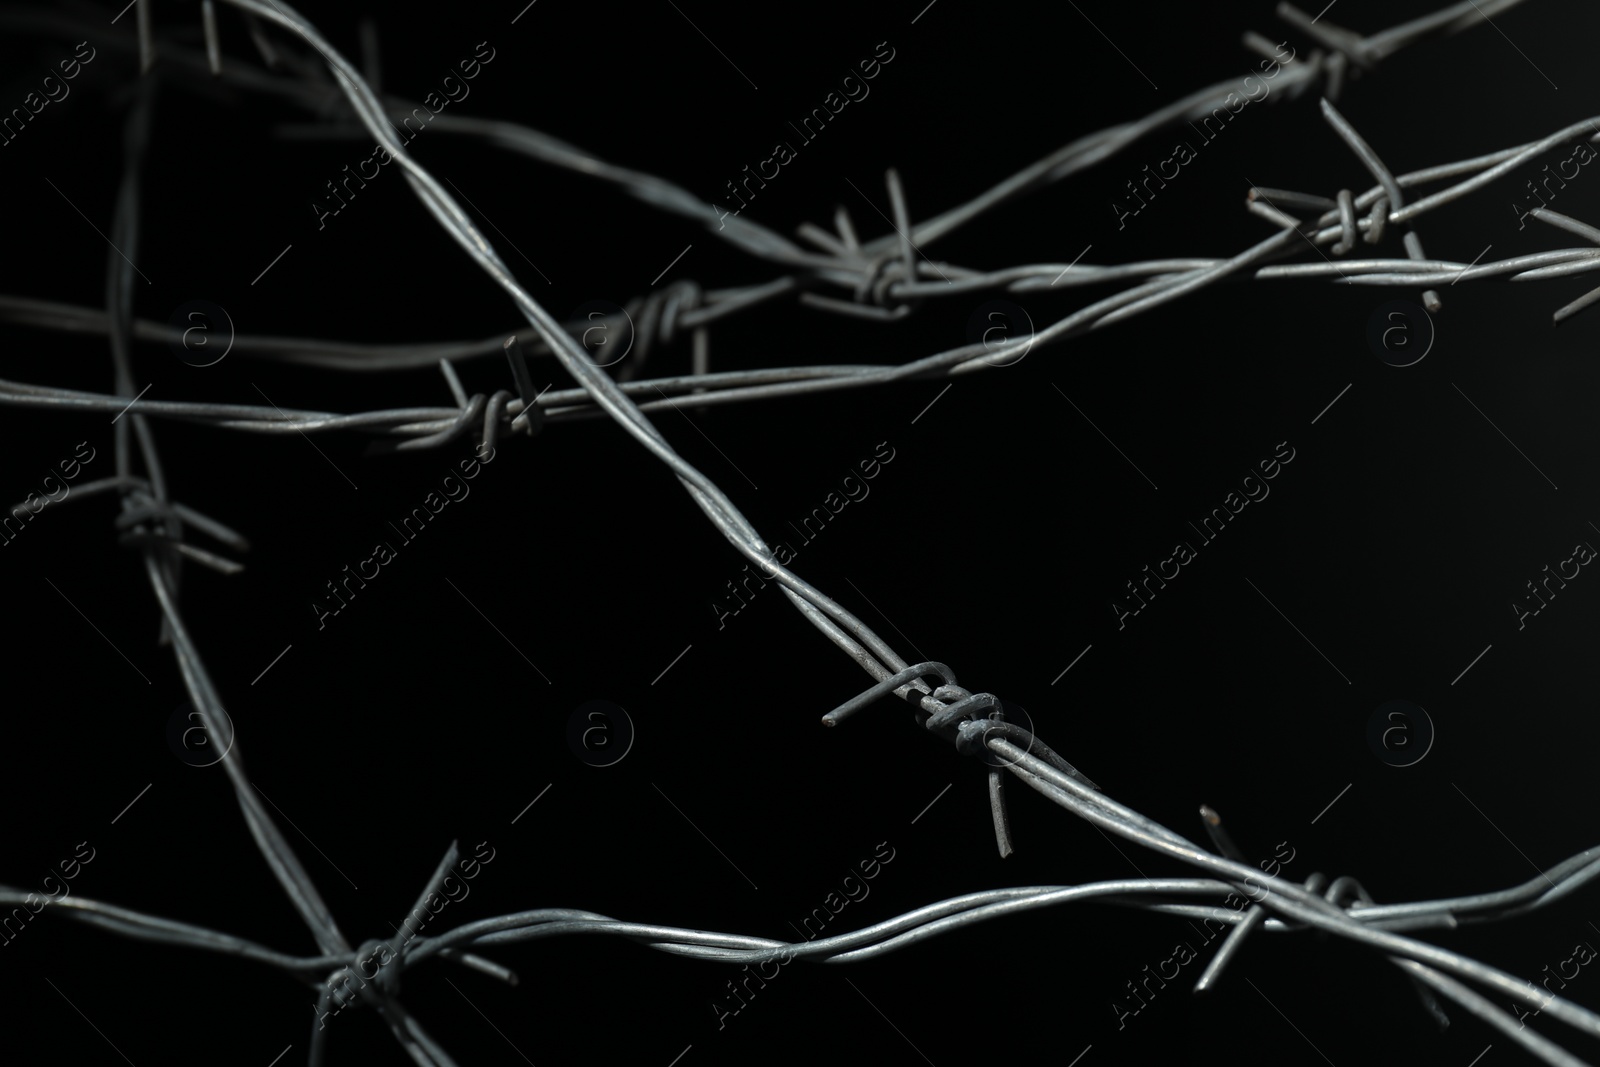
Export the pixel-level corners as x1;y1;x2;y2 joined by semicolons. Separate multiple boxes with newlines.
0;0;1600;1067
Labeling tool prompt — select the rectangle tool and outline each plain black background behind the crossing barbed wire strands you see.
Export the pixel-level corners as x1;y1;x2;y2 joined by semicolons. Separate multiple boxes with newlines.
0;0;1600;1067
